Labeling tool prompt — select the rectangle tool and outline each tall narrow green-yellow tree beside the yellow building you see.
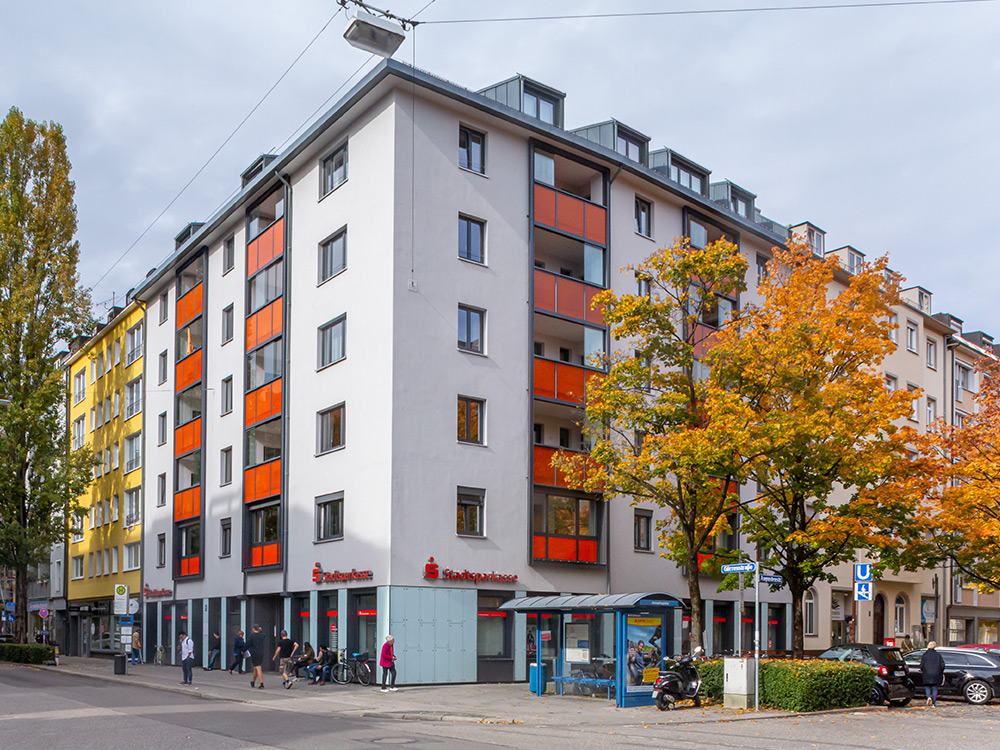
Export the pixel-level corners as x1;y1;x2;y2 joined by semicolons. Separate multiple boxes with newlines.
0;108;92;642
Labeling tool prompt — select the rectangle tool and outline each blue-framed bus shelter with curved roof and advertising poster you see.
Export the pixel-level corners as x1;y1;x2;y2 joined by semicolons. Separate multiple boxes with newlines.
500;592;684;708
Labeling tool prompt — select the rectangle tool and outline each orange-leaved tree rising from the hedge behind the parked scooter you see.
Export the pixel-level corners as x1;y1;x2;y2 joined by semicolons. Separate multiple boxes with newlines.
707;242;917;657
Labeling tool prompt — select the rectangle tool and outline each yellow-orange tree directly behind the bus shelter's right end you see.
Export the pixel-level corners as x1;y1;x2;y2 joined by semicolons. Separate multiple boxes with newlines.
553;240;747;649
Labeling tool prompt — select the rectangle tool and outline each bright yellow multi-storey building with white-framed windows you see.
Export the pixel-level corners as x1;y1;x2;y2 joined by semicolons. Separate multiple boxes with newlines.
66;302;144;656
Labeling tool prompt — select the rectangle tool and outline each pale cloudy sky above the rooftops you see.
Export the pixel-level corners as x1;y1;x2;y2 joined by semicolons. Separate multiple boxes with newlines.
0;0;1000;332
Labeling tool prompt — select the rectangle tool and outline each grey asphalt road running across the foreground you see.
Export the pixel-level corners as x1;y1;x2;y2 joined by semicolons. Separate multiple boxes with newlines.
0;665;1000;750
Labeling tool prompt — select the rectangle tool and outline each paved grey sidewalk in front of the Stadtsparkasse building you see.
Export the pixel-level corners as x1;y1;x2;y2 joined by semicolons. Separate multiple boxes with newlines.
32;656;865;727
